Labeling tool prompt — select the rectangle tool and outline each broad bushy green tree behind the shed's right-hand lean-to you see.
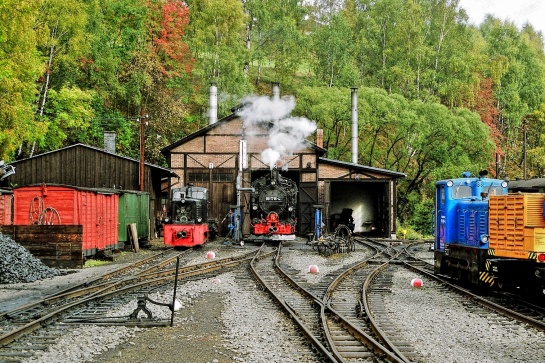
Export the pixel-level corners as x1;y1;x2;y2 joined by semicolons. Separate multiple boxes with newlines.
295;87;495;228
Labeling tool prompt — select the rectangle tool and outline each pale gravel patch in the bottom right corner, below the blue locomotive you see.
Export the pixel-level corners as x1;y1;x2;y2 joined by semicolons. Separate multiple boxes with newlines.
386;270;545;363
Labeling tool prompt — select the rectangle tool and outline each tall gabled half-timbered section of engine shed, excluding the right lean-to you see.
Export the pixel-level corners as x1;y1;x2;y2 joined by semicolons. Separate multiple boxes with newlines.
162;114;325;235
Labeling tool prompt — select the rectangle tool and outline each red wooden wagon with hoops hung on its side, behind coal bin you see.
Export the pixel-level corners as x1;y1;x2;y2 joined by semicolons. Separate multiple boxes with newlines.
13;184;119;256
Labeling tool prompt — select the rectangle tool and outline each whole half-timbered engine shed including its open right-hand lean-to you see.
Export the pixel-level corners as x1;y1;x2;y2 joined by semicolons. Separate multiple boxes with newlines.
161;89;405;238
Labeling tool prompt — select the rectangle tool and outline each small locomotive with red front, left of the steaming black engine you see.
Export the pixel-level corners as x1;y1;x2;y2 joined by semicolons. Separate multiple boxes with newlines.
163;185;216;247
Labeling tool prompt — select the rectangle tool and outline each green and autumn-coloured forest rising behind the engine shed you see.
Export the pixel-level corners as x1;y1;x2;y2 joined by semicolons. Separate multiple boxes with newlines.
0;0;545;234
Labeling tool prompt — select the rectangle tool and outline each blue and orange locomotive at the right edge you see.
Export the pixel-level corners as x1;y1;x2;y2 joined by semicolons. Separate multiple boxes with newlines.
434;172;545;292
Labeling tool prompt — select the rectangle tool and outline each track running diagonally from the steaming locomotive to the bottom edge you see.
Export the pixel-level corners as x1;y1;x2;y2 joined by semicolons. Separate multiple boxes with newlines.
251;240;403;362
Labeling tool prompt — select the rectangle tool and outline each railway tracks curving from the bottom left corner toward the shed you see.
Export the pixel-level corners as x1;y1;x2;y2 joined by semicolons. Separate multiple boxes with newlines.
0;249;257;363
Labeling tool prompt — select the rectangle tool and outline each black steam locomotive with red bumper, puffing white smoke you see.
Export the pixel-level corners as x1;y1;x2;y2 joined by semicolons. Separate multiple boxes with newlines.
249;169;298;240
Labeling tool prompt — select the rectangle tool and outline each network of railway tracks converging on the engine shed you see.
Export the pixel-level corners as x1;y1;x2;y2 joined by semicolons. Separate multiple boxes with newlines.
4;237;539;363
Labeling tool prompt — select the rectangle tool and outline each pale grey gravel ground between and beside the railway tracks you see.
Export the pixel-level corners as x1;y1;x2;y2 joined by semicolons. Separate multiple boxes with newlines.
5;241;545;363
